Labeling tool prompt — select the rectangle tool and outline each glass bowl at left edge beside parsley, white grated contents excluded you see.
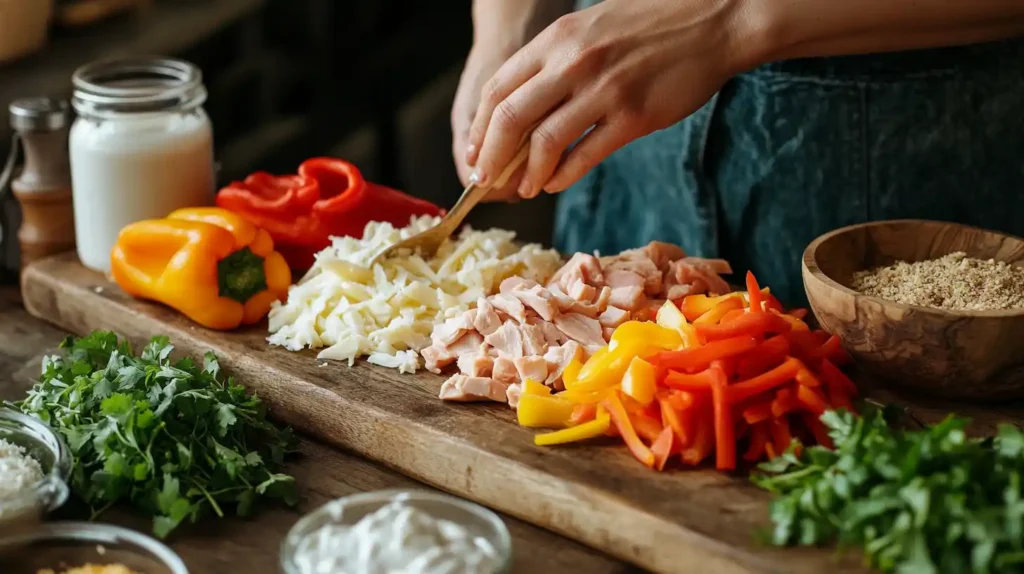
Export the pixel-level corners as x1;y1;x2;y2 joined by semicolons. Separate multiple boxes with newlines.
0;408;72;525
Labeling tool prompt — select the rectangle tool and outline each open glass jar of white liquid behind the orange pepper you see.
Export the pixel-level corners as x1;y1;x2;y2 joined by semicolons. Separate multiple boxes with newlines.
71;57;214;273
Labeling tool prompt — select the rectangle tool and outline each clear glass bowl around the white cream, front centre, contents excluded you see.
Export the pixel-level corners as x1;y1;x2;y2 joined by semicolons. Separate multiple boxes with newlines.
281;489;512;574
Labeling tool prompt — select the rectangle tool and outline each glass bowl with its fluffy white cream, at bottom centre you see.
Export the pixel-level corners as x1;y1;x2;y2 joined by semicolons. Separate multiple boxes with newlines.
281;490;512;574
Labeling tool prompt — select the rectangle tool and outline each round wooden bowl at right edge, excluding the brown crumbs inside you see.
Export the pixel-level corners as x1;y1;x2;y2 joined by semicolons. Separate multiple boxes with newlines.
803;220;1024;400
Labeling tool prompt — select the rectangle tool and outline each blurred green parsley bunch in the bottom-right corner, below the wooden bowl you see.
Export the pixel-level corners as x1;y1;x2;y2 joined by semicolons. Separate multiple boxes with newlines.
754;409;1024;574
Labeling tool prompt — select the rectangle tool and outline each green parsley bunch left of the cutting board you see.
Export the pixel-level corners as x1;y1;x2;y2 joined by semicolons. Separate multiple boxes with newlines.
11;332;296;537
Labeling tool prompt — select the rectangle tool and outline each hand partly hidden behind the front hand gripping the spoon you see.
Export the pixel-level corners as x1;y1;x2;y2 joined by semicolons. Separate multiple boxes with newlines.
452;43;521;202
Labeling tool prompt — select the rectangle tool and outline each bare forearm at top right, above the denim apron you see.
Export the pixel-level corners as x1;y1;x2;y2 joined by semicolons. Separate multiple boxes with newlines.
736;0;1024;64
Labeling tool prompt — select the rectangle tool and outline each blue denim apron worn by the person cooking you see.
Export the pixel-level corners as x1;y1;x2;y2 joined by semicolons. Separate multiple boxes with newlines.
555;0;1024;306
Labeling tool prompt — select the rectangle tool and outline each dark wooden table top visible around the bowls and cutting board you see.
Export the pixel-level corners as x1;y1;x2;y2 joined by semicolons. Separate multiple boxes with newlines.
0;288;639;574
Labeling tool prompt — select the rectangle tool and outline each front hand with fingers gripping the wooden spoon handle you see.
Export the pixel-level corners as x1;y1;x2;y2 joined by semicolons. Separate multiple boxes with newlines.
467;0;757;197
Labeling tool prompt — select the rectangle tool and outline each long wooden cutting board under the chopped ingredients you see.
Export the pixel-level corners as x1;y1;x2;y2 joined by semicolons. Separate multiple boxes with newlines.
23;254;1011;574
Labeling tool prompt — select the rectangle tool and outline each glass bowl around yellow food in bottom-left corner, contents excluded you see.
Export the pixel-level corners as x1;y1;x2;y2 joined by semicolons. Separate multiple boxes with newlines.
0;522;188;574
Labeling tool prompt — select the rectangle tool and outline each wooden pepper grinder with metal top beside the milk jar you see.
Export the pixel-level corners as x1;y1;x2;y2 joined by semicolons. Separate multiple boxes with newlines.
0;97;75;270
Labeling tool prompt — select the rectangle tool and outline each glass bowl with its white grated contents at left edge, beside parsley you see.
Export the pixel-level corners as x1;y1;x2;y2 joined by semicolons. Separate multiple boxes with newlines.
0;408;72;526
